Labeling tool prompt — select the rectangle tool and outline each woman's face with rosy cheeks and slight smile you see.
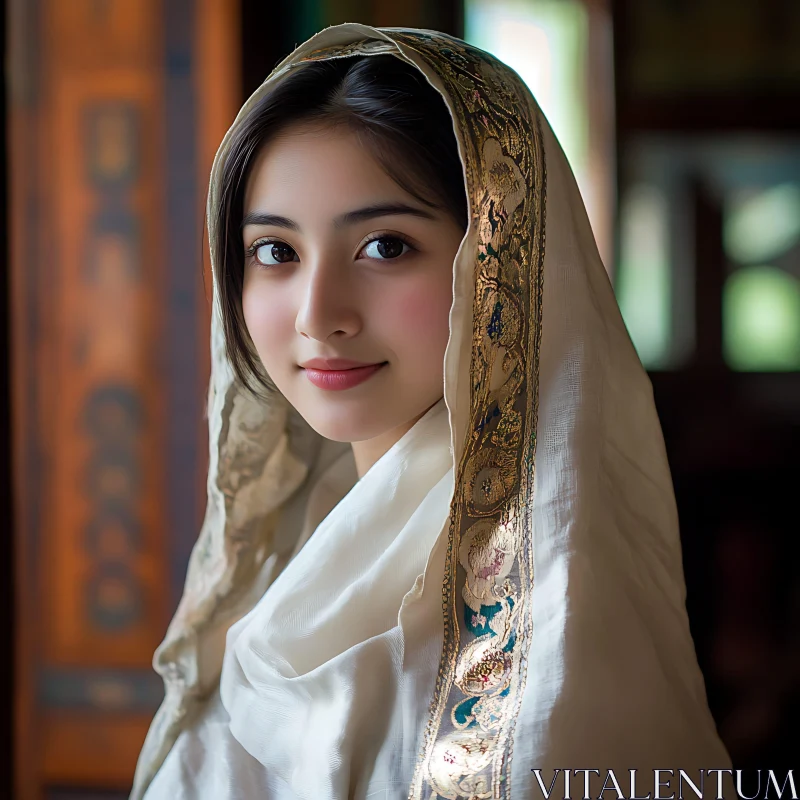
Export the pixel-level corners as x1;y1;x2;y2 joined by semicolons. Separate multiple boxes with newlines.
242;125;464;450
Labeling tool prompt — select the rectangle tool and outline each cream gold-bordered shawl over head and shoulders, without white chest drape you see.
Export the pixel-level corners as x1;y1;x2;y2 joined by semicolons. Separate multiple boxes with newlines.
132;24;730;800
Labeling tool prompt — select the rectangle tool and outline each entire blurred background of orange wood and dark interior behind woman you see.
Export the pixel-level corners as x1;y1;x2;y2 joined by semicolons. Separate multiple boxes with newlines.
0;0;800;800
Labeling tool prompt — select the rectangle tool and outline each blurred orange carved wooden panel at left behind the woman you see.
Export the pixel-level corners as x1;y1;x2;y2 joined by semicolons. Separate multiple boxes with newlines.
9;0;239;800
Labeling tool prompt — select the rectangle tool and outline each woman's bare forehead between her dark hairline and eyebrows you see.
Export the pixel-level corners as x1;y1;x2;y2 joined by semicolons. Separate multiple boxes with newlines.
244;125;413;216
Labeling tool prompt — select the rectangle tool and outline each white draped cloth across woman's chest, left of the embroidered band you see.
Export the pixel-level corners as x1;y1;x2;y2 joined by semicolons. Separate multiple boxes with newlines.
145;400;453;800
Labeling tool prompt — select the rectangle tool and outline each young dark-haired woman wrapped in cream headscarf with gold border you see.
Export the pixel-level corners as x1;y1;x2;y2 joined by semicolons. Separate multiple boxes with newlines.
132;24;729;800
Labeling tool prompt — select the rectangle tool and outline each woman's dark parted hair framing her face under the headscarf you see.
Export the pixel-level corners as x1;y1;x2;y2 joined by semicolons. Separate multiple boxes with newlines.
211;55;468;391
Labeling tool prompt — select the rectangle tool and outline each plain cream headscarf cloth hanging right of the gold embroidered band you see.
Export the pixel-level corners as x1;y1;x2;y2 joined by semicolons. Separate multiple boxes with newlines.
512;122;730;798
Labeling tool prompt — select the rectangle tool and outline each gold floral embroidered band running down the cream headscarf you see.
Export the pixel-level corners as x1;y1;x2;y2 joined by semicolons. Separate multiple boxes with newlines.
390;31;546;800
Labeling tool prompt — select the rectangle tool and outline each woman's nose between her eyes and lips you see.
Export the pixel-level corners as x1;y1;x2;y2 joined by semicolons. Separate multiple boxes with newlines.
295;257;361;342
